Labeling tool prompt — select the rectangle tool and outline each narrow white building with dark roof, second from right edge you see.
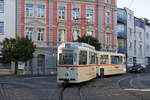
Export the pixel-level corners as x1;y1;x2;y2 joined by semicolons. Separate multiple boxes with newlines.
133;17;145;65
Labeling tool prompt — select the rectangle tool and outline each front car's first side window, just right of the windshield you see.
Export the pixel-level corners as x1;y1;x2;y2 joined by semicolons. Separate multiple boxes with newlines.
79;51;87;65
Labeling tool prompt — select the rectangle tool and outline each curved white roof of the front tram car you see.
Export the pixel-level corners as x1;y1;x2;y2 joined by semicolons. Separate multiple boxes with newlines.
58;42;95;50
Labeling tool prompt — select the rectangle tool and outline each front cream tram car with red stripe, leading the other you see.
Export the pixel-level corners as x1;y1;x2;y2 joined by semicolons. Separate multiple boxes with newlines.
57;42;97;83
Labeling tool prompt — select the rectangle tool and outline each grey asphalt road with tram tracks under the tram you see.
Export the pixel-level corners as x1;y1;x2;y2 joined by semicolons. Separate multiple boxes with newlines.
0;72;150;100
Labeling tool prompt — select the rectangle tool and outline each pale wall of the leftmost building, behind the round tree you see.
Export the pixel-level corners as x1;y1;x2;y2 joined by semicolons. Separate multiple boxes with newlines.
0;0;16;75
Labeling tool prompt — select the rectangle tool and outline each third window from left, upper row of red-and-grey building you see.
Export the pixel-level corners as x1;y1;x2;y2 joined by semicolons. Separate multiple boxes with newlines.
58;6;66;20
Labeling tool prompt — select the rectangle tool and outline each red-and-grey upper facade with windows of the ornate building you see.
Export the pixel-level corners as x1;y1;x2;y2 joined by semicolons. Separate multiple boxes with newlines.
17;0;117;51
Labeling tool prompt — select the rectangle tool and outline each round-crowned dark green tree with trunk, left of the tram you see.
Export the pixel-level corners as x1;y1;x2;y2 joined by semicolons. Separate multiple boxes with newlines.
2;37;36;74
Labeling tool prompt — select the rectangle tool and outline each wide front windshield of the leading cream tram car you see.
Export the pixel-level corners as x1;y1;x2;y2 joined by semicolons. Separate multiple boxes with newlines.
59;52;77;65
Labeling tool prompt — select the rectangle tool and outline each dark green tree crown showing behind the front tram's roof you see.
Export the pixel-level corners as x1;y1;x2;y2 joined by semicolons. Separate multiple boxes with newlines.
74;35;101;51
